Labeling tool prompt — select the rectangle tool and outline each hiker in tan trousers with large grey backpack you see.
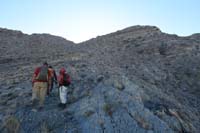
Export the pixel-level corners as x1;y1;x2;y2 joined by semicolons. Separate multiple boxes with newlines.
32;62;51;109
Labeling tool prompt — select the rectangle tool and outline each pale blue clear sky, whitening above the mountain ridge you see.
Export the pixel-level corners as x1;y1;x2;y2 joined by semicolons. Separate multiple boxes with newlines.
0;0;200;43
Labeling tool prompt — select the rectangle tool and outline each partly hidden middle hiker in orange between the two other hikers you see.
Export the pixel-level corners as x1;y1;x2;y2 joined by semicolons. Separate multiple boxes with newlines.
47;66;57;95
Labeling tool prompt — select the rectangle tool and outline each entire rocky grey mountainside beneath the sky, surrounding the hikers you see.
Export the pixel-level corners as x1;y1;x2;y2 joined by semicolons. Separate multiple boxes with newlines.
0;26;200;133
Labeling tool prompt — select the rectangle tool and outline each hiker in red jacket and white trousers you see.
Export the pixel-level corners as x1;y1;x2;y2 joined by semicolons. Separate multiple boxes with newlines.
58;68;71;109
